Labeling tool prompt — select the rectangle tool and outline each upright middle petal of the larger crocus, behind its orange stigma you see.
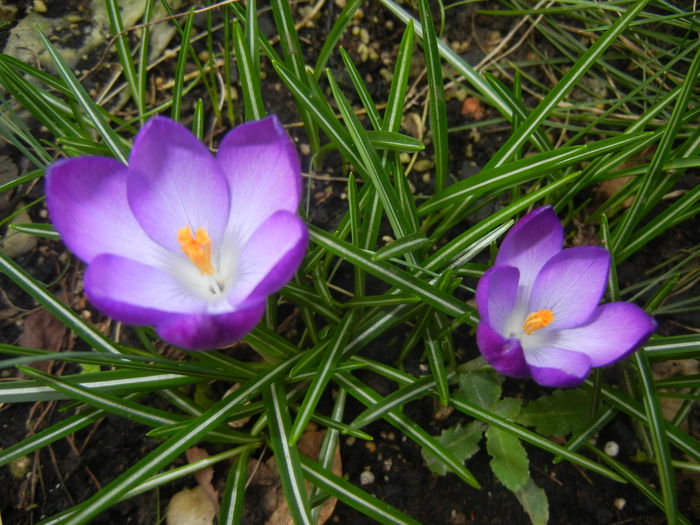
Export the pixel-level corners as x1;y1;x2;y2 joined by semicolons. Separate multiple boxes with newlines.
127;117;229;253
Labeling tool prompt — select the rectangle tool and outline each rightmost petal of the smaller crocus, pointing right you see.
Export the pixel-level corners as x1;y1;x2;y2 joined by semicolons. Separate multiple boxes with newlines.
553;303;656;367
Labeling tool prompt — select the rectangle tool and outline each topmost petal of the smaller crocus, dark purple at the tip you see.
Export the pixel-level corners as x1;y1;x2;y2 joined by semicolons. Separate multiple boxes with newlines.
496;206;564;296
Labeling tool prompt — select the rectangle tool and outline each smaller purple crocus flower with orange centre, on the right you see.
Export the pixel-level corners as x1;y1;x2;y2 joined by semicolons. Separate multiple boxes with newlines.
476;206;656;387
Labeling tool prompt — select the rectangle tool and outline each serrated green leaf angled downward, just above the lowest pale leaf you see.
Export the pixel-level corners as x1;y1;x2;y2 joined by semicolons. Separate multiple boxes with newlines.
486;427;530;492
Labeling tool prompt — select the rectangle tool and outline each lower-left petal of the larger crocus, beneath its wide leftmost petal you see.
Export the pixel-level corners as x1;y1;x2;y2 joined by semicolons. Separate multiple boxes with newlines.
85;254;208;325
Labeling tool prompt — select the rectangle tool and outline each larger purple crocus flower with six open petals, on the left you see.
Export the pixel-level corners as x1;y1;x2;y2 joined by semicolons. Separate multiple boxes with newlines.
46;116;308;350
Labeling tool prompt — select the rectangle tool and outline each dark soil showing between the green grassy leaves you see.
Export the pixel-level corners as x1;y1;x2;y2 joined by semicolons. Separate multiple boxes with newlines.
0;1;700;525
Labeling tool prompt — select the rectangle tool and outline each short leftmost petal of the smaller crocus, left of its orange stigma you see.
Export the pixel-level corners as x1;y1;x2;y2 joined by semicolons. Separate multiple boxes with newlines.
476;266;519;334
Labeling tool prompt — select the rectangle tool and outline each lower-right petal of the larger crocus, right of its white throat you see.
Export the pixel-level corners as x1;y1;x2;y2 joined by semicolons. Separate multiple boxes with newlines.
228;211;308;308
